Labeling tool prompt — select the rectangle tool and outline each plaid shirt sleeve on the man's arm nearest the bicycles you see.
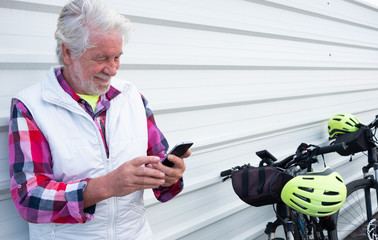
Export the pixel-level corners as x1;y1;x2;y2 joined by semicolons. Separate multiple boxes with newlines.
142;95;184;202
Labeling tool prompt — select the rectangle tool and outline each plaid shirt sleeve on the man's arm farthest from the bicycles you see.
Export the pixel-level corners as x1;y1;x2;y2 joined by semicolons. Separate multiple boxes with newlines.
9;99;94;223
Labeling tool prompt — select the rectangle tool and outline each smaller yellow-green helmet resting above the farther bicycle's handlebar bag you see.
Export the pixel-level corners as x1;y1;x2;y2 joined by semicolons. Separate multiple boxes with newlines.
328;113;361;139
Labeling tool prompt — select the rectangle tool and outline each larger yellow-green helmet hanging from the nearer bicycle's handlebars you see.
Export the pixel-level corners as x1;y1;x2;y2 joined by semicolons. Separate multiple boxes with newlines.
281;167;347;217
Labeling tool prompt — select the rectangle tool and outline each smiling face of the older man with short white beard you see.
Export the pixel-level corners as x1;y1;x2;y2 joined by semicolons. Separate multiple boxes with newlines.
63;33;122;95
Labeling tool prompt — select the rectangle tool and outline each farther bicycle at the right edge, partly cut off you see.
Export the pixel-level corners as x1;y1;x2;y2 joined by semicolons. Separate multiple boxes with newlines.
335;115;378;240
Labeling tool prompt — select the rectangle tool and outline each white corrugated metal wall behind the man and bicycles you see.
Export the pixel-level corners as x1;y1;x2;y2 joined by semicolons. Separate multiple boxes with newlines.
0;0;378;240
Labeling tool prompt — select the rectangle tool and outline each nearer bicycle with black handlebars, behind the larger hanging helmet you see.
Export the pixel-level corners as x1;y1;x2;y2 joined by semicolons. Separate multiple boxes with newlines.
220;143;345;240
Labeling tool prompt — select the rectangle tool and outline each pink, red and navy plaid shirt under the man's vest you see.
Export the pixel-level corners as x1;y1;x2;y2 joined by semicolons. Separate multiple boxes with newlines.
9;69;183;223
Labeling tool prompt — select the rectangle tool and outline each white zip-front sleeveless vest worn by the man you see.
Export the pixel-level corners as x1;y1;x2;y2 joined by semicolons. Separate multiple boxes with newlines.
16;68;152;240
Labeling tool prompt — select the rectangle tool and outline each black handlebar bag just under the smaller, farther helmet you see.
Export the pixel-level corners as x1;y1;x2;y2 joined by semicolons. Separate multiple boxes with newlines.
334;127;375;156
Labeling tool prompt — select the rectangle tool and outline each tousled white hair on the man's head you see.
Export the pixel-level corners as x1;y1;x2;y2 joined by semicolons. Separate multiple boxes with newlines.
55;0;131;65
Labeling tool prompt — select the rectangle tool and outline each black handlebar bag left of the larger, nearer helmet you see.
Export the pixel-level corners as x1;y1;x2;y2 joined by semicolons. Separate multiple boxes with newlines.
232;165;293;207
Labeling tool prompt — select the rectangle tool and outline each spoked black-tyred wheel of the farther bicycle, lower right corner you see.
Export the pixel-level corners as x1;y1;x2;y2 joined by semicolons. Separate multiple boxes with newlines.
335;179;377;239
